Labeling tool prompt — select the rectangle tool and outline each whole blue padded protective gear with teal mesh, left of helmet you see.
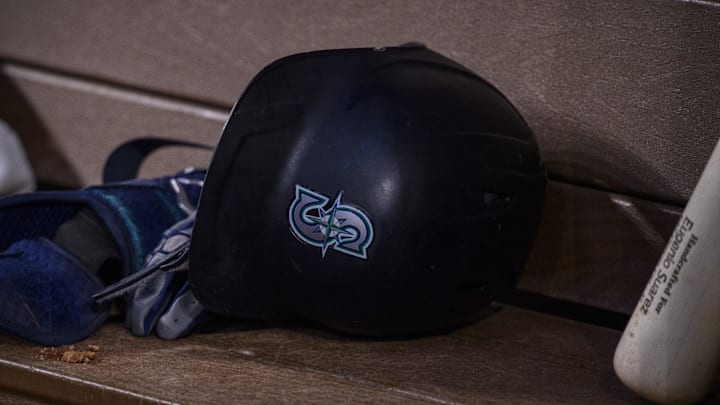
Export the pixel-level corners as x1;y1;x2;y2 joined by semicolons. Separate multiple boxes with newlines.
0;172;204;345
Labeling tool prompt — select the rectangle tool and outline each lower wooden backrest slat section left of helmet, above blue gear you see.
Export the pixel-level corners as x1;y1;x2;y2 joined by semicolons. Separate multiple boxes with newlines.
0;64;222;188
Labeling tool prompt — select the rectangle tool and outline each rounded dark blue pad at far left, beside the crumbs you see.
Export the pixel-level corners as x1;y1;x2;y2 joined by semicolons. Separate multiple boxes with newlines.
0;237;108;346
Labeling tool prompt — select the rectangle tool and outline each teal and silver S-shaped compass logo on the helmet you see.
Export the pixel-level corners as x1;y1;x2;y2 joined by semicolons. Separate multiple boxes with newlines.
288;184;373;259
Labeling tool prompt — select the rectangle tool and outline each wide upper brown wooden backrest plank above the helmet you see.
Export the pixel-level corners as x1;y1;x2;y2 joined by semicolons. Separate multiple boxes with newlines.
0;0;720;202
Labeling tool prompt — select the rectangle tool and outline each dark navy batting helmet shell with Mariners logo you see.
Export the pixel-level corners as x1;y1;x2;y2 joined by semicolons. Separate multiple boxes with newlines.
190;47;546;335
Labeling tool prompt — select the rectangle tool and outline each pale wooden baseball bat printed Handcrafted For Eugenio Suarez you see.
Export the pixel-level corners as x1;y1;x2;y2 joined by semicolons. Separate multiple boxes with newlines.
614;137;720;404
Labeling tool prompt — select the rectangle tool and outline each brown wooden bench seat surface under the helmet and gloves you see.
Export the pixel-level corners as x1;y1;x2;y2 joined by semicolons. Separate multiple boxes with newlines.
0;307;652;404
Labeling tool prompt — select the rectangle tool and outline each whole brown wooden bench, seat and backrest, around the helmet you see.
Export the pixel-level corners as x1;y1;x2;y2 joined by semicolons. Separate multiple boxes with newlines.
0;0;720;404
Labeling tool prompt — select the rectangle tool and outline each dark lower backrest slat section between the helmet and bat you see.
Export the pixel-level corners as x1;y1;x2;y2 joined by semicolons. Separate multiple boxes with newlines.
518;182;682;314
